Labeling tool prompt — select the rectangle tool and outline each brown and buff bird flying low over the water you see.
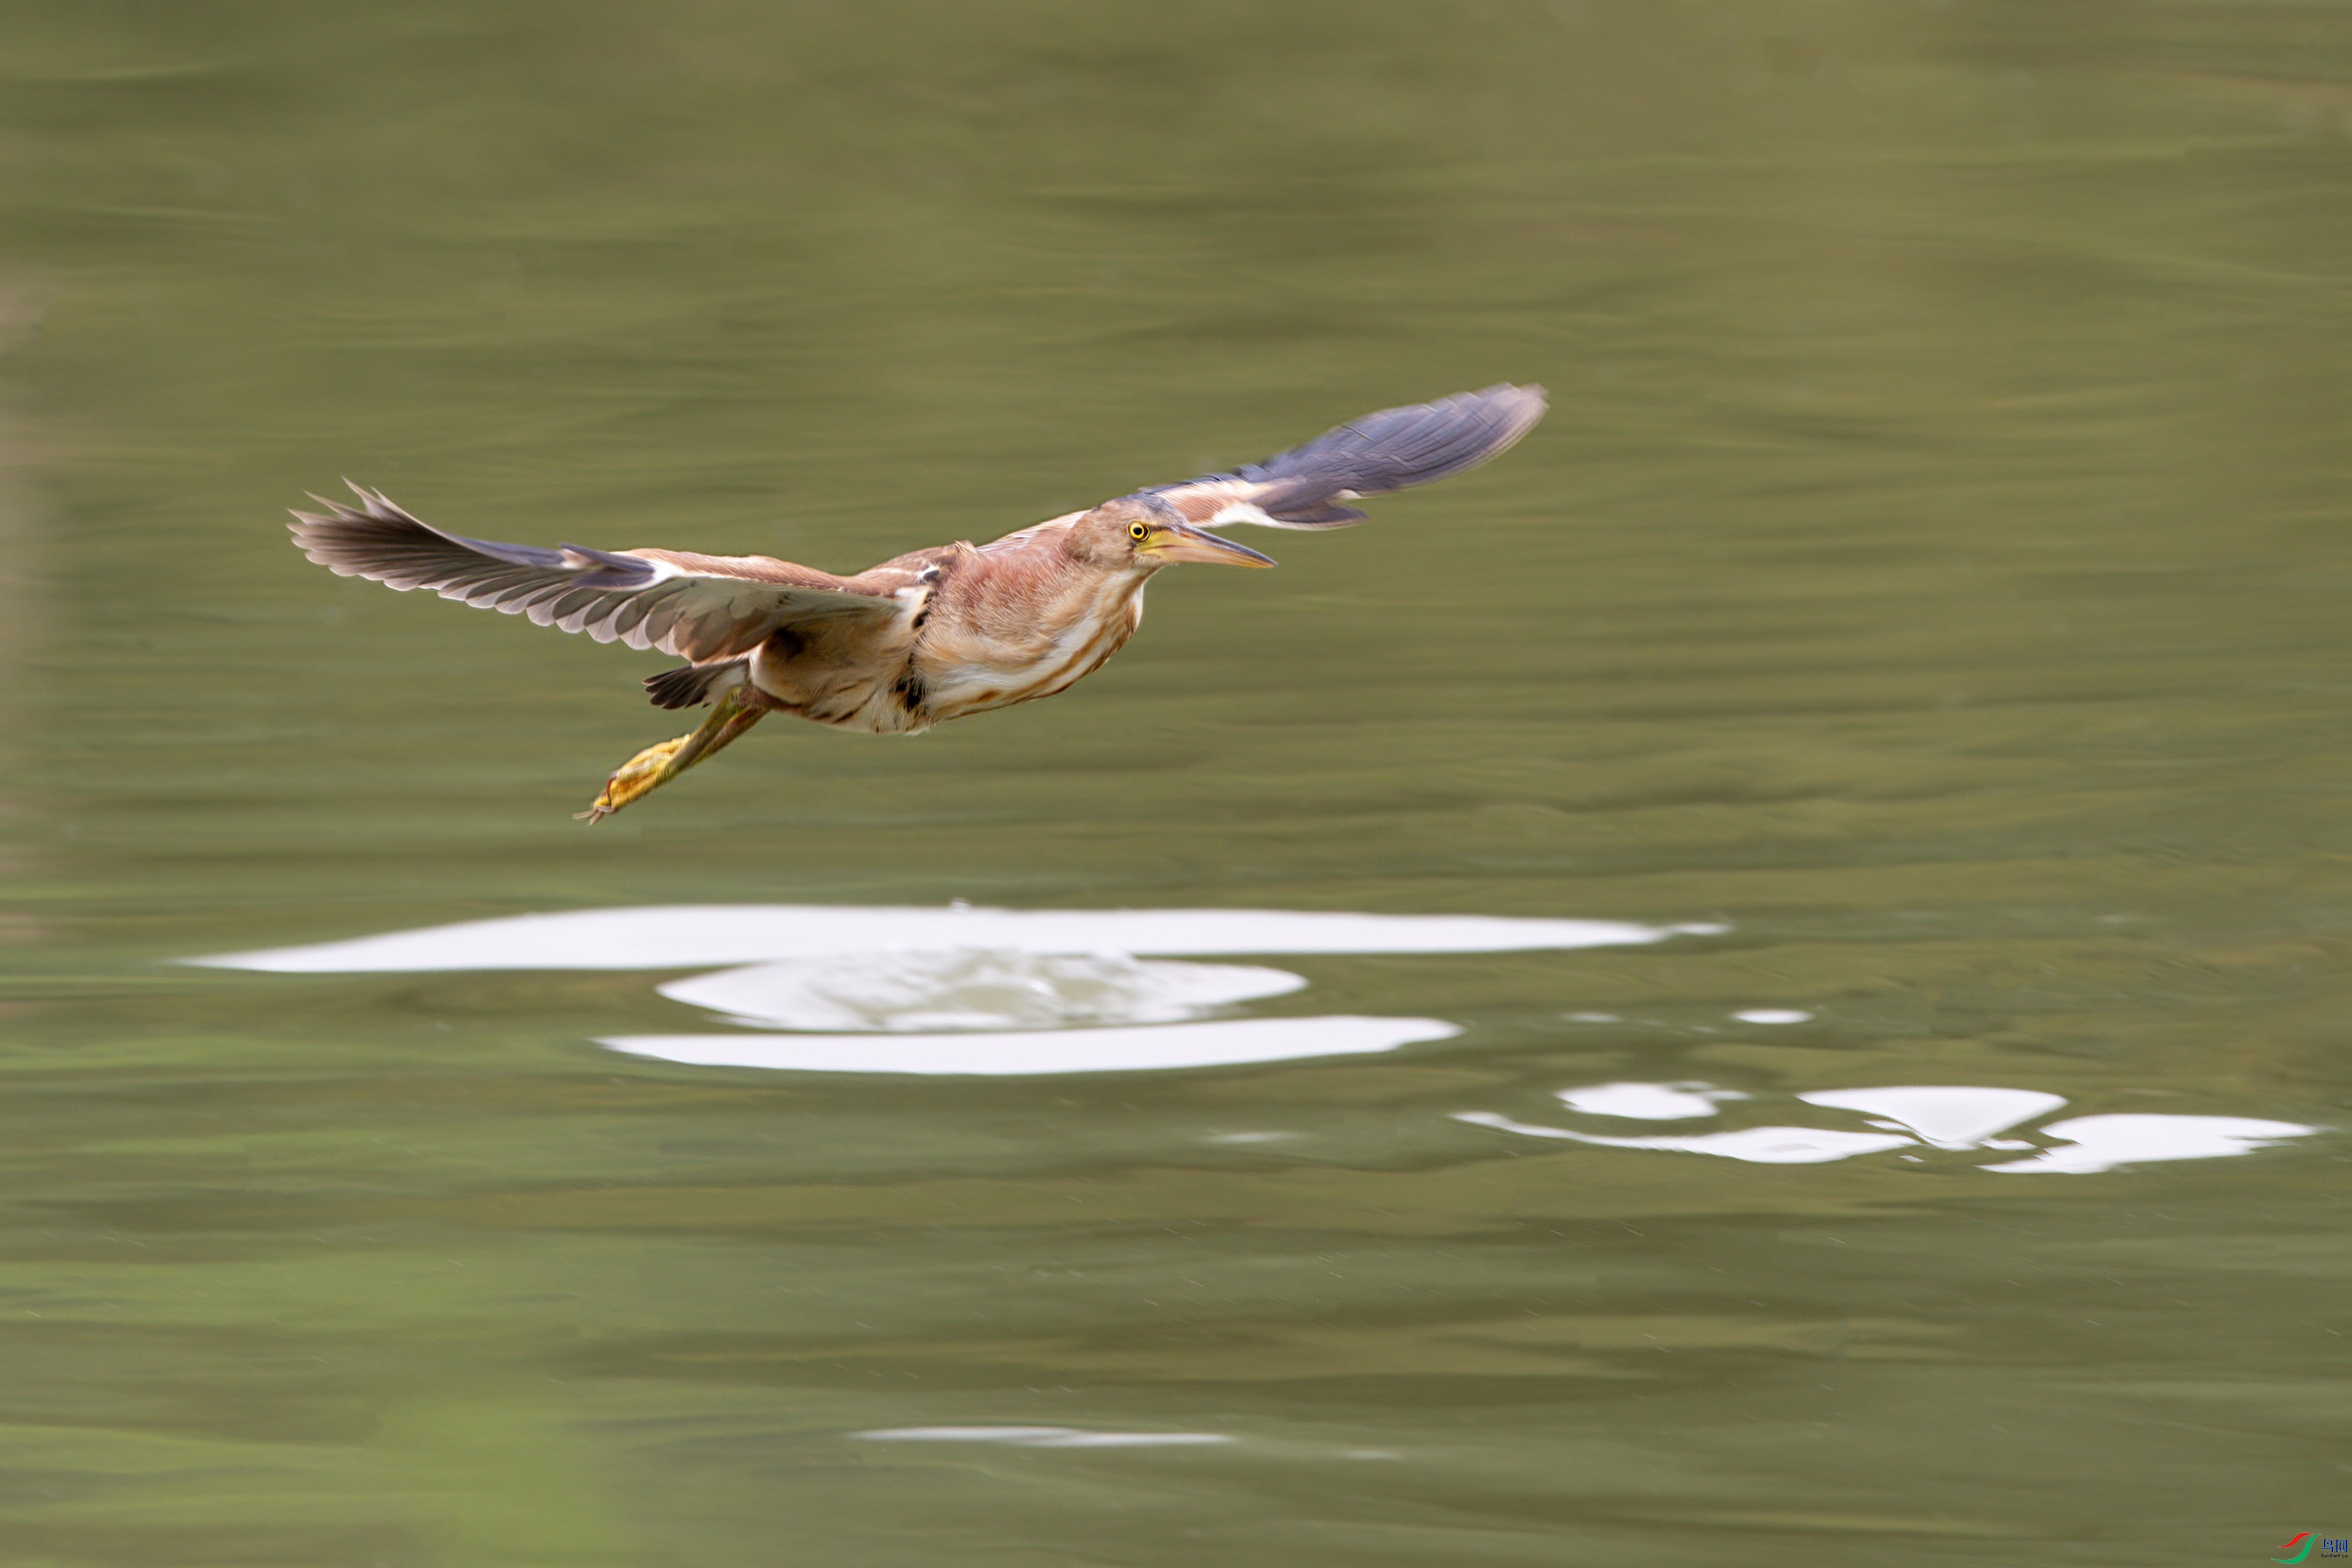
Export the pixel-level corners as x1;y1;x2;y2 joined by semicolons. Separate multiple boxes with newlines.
292;386;1543;822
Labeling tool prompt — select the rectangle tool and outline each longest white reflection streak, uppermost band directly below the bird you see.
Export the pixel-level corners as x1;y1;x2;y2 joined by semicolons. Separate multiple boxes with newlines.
186;902;1724;973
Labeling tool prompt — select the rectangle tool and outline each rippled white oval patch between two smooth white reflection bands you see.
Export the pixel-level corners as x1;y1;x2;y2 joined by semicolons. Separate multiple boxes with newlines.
659;952;1305;1032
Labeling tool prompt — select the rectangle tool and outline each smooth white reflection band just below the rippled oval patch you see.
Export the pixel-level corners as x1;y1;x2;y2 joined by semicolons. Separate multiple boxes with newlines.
597;1015;1461;1076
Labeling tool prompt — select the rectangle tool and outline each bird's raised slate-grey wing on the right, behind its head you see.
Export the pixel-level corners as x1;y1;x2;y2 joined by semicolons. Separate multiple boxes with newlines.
1145;383;1545;529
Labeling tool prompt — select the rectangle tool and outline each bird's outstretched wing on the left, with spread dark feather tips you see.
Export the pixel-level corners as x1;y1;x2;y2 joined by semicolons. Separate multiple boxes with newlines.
292;485;898;661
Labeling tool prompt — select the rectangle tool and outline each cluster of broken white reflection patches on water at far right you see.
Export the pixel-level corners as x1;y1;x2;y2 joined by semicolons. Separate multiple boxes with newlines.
1454;1083;2324;1175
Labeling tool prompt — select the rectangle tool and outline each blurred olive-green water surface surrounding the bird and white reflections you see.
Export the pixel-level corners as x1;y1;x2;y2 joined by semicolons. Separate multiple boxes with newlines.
0;0;2352;1568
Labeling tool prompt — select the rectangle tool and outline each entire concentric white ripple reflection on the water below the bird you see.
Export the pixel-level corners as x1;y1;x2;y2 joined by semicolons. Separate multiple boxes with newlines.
186;902;1724;1074
